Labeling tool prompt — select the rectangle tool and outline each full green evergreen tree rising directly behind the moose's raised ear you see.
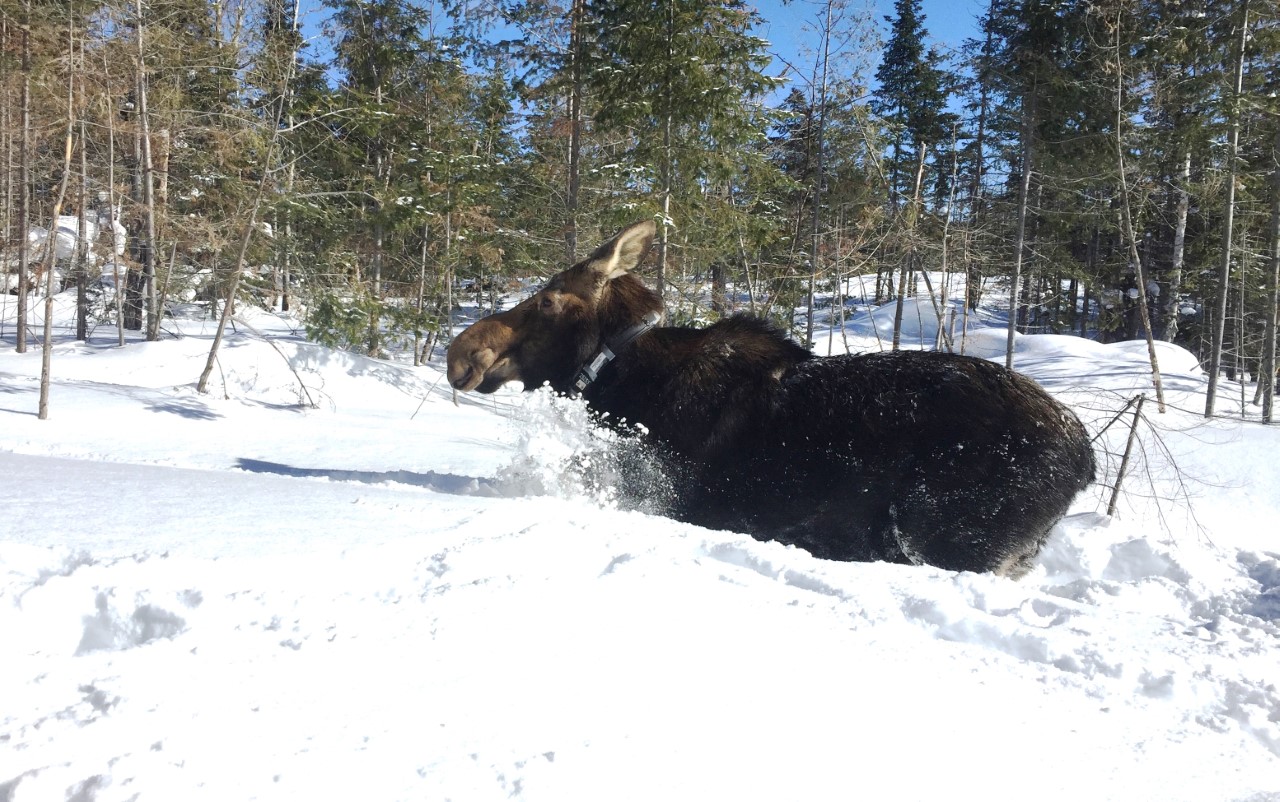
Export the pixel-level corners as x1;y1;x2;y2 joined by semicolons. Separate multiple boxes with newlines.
589;0;777;301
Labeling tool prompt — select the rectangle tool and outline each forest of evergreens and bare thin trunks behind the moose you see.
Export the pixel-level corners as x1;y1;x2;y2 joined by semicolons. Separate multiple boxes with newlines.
0;0;1280;420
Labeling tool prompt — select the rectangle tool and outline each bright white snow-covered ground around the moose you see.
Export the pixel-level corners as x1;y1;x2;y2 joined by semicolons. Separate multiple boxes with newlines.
0;291;1280;802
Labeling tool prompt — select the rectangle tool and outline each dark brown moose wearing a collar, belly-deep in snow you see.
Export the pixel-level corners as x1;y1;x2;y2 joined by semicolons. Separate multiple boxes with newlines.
448;221;1094;578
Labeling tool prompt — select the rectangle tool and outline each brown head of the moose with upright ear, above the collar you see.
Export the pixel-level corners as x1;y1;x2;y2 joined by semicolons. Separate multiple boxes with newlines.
447;220;662;393
